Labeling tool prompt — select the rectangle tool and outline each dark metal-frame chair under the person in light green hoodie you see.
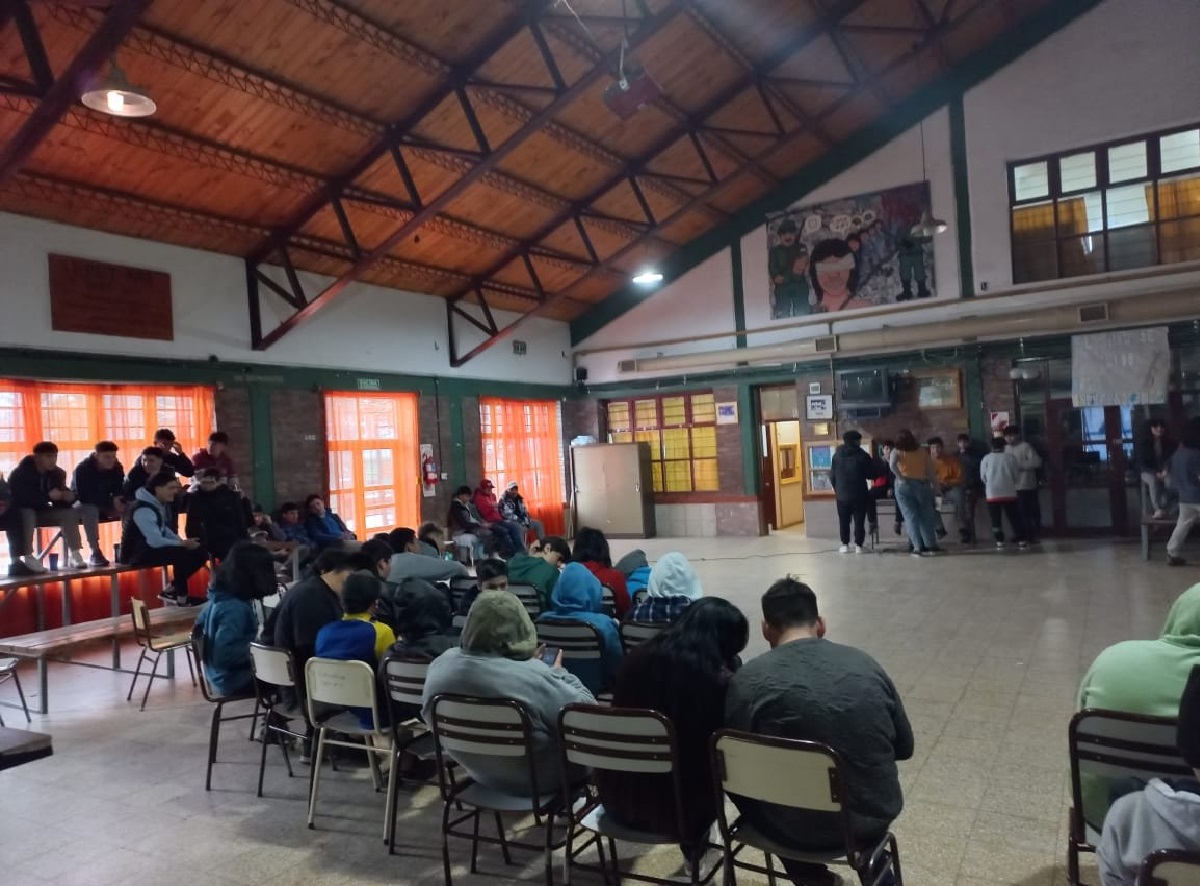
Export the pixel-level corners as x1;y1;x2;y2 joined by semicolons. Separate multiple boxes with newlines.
1067;708;1193;885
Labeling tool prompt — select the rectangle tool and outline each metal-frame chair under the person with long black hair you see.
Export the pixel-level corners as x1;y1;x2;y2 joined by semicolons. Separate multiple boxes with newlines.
558;705;720;886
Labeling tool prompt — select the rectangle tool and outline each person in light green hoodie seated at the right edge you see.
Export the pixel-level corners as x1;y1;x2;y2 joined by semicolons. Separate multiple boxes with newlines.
1079;585;1200;831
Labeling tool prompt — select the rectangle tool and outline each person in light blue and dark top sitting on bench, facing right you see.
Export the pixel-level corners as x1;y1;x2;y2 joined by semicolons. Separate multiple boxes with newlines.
121;472;209;606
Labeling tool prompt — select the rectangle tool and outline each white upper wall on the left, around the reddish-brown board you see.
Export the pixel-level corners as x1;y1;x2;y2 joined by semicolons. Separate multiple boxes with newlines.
0;214;571;385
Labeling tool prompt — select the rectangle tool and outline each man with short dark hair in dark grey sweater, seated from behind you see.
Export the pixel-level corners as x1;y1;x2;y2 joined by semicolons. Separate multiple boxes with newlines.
725;579;913;886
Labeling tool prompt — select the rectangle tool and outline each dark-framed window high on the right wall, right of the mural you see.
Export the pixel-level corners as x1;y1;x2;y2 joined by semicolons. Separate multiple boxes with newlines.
1008;127;1200;283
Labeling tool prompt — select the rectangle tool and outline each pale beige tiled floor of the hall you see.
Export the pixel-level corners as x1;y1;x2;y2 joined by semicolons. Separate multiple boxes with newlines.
0;534;1185;886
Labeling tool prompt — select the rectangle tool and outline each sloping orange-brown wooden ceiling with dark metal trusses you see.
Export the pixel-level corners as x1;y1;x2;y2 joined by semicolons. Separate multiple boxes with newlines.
0;0;1051;357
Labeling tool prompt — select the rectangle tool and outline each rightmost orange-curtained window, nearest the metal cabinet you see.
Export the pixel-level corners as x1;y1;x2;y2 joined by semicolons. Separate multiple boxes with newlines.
479;397;565;535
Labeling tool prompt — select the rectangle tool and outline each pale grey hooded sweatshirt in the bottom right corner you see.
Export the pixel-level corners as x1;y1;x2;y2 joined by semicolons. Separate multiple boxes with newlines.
1097;778;1200;886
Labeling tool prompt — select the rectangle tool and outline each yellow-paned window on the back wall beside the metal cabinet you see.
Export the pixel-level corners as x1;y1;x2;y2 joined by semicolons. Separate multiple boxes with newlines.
607;393;720;492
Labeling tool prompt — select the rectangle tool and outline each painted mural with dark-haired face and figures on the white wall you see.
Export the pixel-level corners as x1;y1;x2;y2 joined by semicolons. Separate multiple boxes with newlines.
767;181;936;319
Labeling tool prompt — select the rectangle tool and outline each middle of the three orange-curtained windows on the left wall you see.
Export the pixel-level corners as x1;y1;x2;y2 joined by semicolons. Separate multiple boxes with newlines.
325;394;421;538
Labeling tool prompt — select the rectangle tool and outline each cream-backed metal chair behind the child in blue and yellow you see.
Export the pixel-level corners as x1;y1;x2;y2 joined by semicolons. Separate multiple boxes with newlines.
304;657;397;839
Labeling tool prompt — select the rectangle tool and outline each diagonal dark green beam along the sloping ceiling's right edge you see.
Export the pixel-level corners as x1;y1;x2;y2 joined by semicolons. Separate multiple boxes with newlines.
571;0;1102;345
